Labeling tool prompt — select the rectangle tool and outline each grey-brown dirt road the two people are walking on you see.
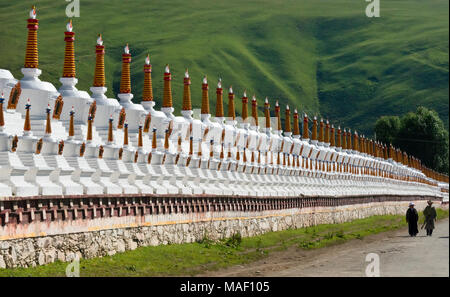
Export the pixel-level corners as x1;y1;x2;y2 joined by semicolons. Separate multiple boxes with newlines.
205;219;449;277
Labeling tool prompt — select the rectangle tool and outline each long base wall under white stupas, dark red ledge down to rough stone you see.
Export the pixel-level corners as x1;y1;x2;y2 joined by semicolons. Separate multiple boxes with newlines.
0;195;442;268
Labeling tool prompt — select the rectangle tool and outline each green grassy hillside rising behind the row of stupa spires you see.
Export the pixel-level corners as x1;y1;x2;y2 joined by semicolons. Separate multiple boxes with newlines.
0;0;449;133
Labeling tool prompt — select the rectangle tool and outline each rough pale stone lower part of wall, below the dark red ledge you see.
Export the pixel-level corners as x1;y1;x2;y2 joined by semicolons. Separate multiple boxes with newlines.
0;194;437;268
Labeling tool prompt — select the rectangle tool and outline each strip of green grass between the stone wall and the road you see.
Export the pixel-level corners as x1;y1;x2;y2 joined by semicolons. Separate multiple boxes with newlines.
0;209;449;276
